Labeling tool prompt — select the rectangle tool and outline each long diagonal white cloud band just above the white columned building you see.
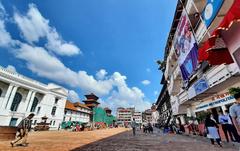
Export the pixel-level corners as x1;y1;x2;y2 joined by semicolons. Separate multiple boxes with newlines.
14;43;112;95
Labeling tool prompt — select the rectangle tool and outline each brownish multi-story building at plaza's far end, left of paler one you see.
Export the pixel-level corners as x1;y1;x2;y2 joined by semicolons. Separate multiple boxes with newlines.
117;107;135;125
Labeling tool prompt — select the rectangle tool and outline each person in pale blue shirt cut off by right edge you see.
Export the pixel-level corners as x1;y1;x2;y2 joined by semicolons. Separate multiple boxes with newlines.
229;92;240;134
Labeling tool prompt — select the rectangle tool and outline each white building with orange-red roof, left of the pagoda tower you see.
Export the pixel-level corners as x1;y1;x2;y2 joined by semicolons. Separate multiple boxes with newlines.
63;100;91;123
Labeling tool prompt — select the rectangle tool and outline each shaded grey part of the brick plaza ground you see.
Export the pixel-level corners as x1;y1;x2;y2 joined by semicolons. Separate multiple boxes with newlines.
72;129;238;151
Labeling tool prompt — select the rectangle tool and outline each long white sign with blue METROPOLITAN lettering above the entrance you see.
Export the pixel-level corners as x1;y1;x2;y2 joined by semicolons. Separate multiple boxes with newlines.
195;96;236;112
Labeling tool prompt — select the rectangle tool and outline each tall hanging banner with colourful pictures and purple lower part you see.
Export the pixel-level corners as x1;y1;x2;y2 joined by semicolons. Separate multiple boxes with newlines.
174;11;198;81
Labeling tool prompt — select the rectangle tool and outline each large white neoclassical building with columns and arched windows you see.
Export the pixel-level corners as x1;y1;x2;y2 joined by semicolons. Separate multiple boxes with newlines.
0;66;68;130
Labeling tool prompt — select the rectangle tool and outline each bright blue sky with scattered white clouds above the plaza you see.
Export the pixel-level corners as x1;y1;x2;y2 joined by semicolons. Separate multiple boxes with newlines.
0;0;176;110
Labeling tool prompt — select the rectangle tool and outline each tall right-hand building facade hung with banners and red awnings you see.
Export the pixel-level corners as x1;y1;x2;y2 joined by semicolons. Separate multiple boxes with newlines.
163;0;240;124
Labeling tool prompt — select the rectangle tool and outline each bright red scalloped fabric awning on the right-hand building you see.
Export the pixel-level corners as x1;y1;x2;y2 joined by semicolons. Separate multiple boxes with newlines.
198;0;240;65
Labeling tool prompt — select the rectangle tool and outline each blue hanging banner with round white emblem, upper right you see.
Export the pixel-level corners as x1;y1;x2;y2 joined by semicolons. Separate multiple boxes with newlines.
202;0;224;28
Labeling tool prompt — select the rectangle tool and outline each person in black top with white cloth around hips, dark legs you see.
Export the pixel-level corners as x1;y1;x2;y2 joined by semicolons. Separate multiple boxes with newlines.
205;114;222;147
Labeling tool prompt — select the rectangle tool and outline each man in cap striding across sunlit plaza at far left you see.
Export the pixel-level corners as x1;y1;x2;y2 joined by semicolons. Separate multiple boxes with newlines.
10;113;34;147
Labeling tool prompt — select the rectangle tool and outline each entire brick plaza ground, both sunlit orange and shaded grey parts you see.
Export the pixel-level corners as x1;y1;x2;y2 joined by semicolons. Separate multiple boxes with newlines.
0;128;238;151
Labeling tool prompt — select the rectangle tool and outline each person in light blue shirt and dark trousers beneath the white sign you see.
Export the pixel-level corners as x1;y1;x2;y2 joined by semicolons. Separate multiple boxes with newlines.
218;111;234;142
